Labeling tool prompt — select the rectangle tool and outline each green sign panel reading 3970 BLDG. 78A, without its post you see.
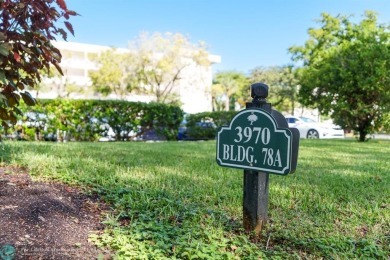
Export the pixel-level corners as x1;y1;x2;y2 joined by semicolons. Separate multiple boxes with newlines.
217;109;293;175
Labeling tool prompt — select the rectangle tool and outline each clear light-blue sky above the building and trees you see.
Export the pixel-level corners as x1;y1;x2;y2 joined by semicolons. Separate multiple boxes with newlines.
66;0;390;73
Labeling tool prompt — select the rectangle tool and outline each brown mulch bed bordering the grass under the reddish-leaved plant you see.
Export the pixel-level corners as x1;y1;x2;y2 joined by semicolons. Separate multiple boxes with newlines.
0;166;111;259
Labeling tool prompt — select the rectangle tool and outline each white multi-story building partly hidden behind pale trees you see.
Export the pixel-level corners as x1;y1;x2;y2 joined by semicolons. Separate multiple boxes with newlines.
39;42;221;113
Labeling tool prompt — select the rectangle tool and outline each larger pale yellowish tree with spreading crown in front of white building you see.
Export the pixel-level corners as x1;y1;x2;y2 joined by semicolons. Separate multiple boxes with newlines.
130;33;210;103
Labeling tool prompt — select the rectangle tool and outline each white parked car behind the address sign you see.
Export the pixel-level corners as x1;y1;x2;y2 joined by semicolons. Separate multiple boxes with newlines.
285;116;344;139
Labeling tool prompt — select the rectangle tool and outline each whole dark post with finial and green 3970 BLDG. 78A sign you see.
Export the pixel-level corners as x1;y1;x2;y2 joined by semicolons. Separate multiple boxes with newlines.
216;83;299;235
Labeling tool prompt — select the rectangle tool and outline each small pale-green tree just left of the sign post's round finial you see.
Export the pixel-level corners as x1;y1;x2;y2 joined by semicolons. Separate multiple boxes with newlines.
212;71;250;111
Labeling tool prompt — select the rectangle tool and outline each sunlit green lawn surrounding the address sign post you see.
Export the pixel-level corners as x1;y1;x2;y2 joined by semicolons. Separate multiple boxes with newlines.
1;140;390;259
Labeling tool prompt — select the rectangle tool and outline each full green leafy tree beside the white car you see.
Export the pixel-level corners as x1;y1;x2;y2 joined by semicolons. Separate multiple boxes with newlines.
289;11;390;141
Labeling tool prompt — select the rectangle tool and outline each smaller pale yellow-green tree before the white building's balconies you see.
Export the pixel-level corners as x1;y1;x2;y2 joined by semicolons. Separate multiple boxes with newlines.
89;48;137;98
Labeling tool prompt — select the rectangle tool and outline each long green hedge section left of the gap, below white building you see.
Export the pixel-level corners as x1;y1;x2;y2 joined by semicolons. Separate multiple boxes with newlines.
17;99;183;141
